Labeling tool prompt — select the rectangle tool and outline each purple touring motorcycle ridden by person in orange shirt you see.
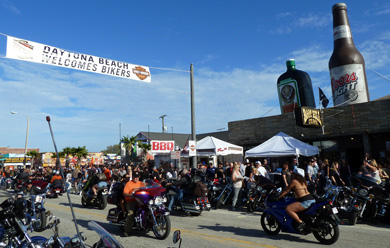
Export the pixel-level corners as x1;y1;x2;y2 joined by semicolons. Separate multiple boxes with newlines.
107;179;171;239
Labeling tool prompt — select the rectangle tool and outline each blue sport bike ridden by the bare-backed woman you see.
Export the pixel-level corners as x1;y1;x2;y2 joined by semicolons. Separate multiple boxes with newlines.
260;189;340;245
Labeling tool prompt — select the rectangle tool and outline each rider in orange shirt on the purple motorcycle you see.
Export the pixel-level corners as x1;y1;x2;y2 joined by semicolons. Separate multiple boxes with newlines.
123;171;145;237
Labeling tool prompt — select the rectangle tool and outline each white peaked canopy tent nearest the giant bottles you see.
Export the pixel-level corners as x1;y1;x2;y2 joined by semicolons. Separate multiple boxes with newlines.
245;132;319;157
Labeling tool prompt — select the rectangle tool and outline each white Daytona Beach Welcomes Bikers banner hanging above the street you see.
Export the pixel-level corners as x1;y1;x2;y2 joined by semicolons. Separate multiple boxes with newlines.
6;36;151;83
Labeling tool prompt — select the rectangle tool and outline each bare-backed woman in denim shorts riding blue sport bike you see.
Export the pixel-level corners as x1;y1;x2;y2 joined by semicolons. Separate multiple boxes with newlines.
278;168;315;231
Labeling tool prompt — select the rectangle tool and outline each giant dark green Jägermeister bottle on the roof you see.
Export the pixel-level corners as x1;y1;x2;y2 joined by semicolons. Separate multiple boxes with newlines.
277;59;316;114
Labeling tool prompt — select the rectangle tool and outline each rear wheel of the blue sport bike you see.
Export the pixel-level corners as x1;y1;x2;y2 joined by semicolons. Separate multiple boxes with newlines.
313;219;340;245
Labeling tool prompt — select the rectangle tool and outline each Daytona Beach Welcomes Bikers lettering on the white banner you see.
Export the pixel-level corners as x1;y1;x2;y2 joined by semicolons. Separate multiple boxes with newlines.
42;46;131;78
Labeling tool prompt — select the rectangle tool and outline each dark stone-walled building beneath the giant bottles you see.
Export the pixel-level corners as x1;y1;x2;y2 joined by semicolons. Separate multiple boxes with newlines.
228;96;390;171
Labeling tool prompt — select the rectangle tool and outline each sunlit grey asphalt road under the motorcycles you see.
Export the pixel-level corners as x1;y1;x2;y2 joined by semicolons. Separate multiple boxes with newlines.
0;191;390;248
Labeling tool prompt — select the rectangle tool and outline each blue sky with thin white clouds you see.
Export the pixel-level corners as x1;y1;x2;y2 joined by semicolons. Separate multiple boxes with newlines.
0;0;390;152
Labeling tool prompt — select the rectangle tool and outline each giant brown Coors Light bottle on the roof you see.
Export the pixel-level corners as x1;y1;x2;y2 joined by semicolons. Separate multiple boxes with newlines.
329;3;370;106
